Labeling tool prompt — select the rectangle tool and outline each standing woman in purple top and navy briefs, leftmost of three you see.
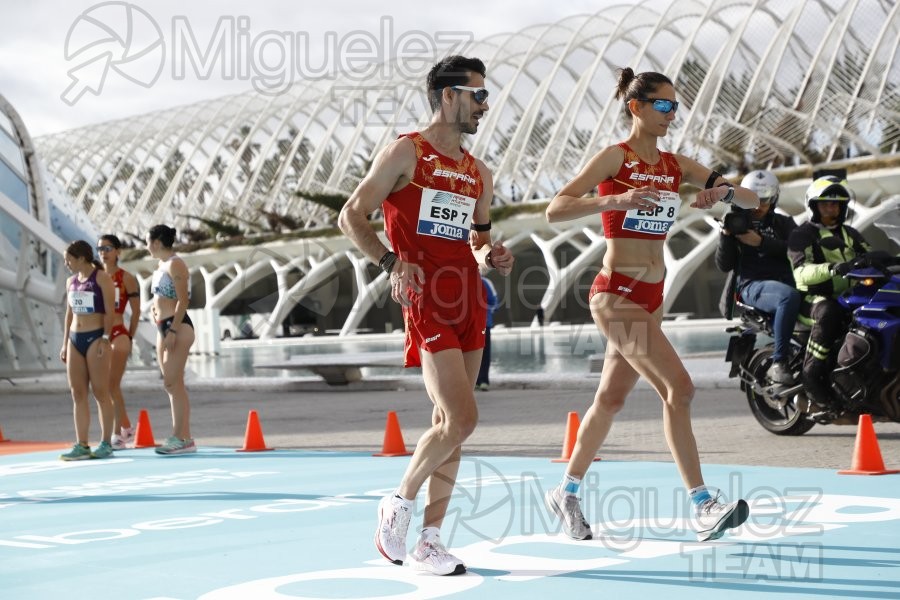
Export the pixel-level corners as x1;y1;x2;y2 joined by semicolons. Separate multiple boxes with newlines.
59;240;114;461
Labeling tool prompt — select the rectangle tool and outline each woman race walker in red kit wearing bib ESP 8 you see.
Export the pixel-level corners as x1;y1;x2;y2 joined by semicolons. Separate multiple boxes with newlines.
545;68;759;541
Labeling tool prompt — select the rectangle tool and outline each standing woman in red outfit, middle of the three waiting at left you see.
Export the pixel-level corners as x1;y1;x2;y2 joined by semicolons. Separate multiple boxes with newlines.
97;233;141;450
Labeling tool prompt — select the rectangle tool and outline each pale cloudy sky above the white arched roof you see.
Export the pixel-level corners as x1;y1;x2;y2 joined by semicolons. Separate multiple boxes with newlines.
0;0;612;136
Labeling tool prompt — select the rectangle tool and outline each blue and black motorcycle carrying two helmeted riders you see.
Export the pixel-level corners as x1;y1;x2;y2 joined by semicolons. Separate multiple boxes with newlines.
725;217;900;435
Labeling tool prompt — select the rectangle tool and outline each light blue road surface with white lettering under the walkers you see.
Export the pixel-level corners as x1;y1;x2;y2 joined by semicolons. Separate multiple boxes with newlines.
0;448;900;600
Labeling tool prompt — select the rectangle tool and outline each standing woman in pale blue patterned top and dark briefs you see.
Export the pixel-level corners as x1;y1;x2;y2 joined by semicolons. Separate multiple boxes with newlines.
147;225;197;455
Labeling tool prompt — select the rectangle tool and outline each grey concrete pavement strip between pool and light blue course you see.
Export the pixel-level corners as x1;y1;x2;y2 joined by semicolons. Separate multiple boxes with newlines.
0;356;900;469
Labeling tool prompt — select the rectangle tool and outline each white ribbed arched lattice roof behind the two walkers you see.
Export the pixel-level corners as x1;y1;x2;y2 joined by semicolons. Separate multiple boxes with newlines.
37;0;900;239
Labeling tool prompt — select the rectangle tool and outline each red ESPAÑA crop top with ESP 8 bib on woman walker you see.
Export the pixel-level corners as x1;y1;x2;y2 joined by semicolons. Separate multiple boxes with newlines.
597;142;681;240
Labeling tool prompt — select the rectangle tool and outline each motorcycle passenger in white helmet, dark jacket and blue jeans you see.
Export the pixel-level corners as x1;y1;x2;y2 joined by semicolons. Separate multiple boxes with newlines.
716;171;802;385
